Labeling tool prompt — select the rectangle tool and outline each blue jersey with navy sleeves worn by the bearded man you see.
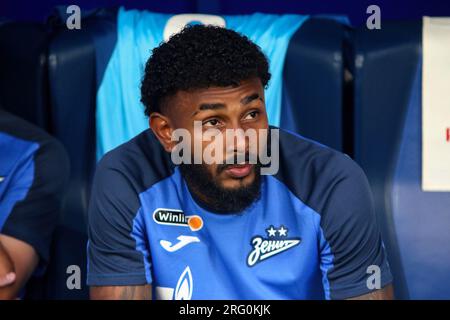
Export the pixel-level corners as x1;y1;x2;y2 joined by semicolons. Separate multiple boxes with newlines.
88;130;392;299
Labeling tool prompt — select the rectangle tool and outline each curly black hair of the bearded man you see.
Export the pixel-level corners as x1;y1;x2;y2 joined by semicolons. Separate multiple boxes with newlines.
141;25;270;116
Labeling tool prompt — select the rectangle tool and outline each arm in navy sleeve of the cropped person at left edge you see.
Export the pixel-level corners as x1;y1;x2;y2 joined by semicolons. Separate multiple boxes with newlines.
0;138;69;299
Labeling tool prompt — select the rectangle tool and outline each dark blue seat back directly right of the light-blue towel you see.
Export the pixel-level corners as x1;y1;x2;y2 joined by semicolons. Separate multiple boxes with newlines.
280;17;352;154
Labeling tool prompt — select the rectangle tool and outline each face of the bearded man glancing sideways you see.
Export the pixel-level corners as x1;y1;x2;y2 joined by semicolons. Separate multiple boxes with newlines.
150;78;268;209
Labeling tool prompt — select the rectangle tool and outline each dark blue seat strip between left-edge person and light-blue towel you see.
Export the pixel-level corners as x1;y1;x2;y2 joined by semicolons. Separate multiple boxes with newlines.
36;10;115;299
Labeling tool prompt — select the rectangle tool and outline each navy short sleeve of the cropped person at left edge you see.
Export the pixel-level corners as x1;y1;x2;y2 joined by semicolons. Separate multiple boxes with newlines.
0;139;70;270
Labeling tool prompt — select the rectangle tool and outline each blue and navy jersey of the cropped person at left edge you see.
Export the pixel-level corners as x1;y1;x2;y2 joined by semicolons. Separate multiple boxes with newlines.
0;110;69;272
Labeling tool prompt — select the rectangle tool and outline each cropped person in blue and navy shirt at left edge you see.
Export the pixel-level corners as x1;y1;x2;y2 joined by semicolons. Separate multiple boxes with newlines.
0;109;69;299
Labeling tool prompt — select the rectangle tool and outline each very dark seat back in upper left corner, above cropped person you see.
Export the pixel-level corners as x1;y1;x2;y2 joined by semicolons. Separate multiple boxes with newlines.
0;22;51;131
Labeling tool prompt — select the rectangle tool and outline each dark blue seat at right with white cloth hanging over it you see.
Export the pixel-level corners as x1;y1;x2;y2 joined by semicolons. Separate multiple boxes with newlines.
354;21;450;299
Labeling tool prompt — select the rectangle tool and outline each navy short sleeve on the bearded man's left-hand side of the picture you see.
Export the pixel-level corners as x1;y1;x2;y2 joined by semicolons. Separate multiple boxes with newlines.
87;154;152;286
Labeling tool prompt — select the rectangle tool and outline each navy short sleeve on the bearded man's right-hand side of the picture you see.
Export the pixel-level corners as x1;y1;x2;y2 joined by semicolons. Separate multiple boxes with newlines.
320;157;392;299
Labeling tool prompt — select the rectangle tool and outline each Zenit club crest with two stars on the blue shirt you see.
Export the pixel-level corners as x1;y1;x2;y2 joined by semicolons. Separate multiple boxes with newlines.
247;226;301;267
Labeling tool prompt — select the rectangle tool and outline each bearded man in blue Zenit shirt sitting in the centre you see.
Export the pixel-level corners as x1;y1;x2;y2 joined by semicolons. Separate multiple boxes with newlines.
88;25;392;299
